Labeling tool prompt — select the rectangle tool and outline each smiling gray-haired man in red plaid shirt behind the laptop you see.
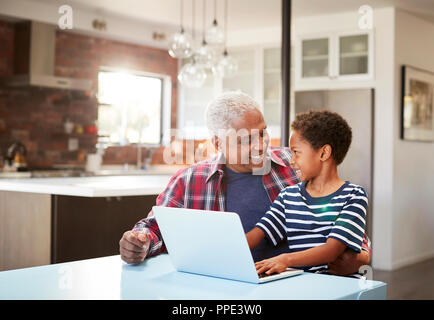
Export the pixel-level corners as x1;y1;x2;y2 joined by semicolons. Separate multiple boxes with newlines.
119;92;370;275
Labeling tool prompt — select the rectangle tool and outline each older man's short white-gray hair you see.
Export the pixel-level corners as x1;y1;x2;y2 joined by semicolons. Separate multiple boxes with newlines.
205;91;261;137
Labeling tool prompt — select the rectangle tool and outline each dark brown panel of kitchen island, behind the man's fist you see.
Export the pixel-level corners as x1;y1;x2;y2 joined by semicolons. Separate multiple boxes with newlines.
51;195;157;263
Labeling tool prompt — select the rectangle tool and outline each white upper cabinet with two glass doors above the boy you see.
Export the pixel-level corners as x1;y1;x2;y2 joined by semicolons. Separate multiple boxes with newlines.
295;30;374;90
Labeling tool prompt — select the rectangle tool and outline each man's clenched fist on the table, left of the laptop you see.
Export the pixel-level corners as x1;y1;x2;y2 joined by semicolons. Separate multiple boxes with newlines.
119;231;149;264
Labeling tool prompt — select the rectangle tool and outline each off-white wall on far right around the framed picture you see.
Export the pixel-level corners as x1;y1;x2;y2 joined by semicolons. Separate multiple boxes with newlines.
392;10;434;268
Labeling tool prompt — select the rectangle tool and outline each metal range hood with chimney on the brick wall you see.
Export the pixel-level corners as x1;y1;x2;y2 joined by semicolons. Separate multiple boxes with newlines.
2;21;92;91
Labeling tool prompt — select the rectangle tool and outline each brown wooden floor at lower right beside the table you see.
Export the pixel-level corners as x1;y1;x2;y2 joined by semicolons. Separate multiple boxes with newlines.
373;259;434;300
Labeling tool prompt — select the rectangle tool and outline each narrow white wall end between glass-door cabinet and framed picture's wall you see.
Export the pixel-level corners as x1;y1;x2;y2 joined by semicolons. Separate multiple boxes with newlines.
370;8;395;270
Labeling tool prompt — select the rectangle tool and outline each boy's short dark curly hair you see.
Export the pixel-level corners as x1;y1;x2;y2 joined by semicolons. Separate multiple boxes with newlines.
291;110;352;165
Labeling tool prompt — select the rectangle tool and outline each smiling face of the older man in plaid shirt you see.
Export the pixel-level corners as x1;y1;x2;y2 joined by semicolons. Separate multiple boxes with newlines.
217;110;270;172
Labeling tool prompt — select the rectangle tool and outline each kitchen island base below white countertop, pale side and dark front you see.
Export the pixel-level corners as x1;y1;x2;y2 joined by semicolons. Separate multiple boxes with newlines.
0;191;157;271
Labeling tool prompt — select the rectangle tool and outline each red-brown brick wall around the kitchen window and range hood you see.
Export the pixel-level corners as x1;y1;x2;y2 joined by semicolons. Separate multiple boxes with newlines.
0;21;178;167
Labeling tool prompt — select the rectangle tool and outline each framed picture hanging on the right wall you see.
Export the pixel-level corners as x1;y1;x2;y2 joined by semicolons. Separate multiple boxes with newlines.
401;65;434;142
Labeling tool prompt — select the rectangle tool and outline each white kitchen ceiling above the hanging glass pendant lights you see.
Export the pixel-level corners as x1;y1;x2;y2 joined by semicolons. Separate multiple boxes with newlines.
38;0;434;30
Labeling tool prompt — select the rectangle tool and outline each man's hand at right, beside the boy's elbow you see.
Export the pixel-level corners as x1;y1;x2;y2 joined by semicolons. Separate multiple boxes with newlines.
328;249;370;276
